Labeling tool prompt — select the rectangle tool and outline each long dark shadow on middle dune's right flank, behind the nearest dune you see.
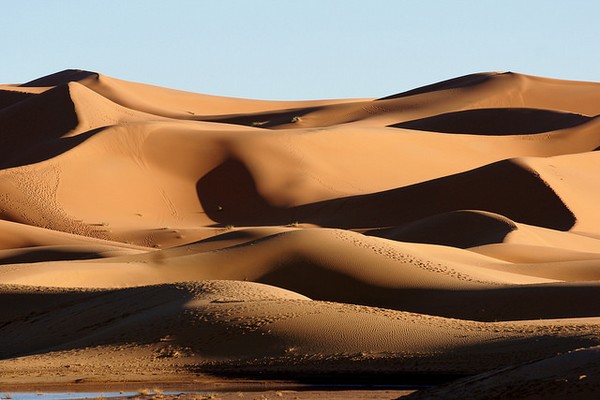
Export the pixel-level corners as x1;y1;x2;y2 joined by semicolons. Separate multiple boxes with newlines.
257;254;600;322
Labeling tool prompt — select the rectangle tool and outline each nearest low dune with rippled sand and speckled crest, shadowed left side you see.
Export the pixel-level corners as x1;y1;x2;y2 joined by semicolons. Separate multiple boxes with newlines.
0;281;598;373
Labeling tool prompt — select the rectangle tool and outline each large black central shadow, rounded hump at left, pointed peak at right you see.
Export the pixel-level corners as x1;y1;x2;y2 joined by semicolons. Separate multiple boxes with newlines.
196;158;576;231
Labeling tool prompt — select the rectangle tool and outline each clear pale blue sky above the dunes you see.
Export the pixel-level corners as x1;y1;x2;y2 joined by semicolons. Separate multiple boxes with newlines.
0;0;600;99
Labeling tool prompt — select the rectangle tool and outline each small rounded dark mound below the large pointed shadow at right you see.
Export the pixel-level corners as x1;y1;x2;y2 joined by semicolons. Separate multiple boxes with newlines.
365;210;517;249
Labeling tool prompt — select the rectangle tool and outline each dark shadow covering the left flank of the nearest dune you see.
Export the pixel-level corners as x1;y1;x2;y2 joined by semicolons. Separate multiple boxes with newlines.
0;285;192;360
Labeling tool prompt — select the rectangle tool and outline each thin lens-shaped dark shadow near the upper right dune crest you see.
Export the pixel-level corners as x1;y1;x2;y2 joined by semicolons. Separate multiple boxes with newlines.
390;108;592;135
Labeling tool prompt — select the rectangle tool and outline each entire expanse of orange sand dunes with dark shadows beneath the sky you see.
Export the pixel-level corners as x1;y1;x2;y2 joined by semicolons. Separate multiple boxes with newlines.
0;70;600;396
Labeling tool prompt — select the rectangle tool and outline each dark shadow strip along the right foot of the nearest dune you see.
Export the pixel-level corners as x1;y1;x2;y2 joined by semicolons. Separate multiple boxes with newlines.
195;335;598;382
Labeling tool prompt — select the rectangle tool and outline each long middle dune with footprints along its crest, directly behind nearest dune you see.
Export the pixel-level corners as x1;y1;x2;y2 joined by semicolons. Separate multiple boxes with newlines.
0;229;600;321
